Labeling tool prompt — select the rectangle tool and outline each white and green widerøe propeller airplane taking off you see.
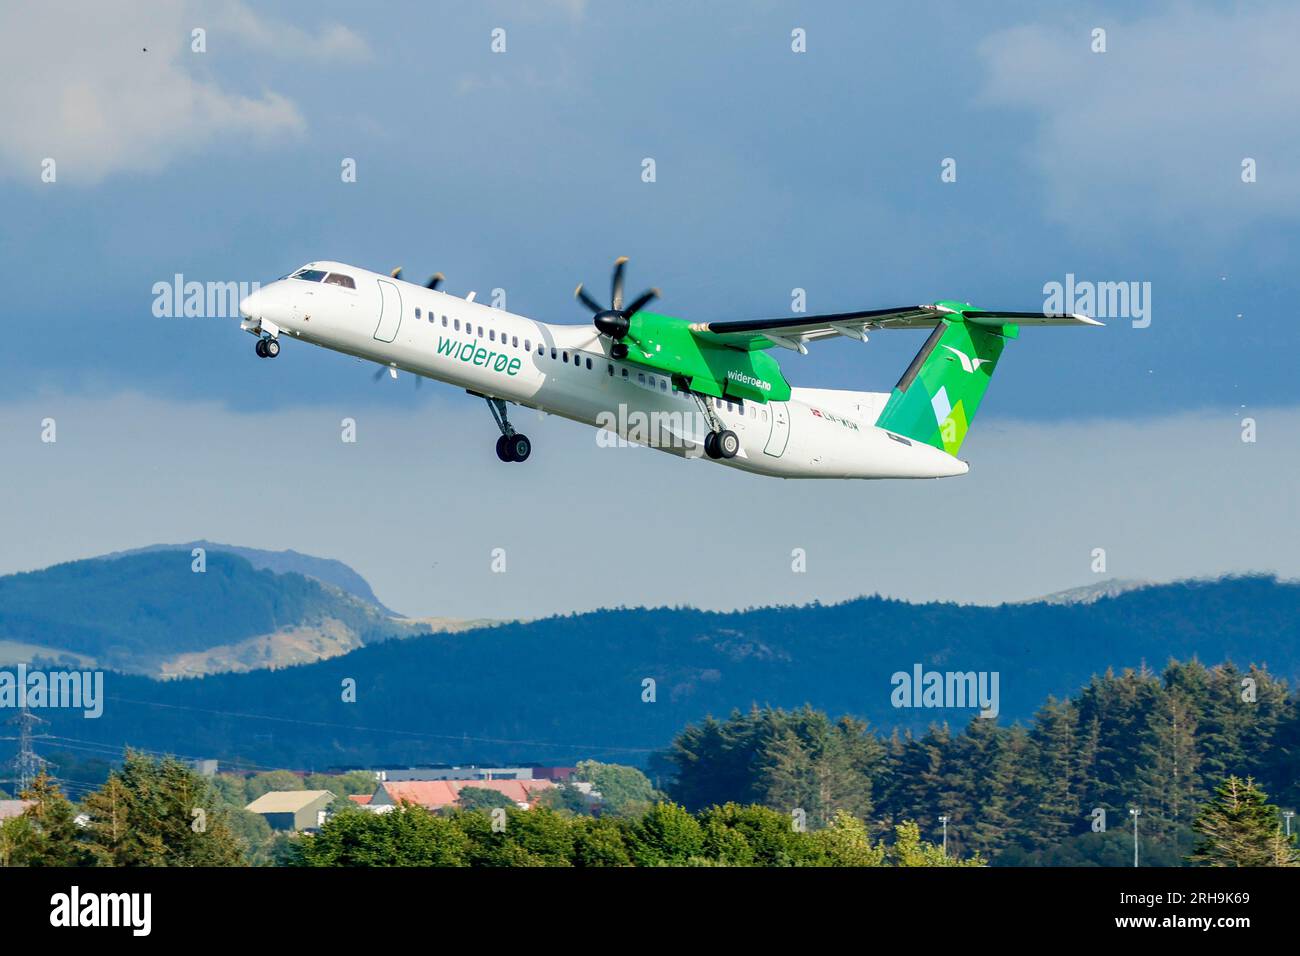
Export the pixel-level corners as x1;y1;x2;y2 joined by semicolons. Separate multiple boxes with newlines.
239;256;1101;479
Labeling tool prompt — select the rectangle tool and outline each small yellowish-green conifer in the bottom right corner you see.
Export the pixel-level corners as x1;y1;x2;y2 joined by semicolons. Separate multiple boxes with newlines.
1188;777;1300;866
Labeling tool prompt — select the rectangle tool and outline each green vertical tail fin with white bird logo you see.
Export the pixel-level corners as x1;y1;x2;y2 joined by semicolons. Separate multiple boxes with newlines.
876;319;1017;455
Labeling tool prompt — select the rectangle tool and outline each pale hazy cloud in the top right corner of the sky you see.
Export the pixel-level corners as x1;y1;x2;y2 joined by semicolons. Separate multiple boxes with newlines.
980;4;1300;232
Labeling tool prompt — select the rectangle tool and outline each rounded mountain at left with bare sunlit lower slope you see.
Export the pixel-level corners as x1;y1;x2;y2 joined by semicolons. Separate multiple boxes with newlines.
0;545;416;676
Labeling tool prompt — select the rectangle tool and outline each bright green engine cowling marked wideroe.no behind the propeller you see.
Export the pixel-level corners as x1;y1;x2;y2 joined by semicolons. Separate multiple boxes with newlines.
623;312;790;402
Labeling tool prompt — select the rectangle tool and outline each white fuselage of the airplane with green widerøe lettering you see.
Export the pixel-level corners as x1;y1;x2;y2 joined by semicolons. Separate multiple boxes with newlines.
241;261;969;479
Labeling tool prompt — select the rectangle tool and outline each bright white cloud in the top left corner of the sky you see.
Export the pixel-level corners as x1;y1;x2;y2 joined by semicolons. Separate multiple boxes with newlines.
0;3;367;185
